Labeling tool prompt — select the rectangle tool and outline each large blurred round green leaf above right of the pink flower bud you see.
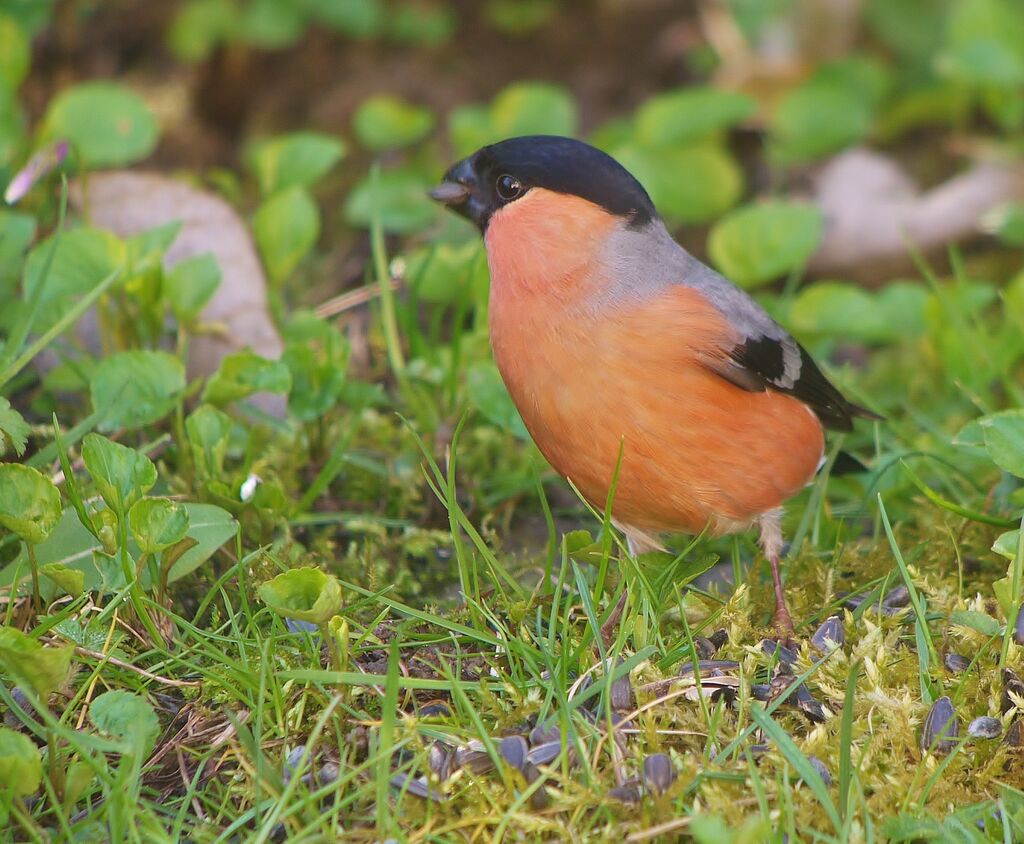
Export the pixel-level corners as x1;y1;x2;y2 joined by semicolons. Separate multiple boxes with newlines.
43;82;159;167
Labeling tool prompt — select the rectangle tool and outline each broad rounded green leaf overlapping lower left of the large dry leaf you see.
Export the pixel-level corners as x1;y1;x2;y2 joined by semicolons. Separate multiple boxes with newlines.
89;350;185;431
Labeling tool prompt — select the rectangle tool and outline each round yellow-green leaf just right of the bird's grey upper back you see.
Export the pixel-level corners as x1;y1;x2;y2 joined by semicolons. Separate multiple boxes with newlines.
708;200;824;287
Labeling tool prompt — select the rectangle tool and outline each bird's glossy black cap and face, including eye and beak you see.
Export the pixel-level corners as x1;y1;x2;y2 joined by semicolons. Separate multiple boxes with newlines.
431;135;657;230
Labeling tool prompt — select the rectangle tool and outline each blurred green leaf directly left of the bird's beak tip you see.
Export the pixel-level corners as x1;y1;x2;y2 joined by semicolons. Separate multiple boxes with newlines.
345;169;437;234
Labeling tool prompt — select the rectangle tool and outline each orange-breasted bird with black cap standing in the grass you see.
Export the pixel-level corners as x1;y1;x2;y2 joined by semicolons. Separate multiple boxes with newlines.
431;135;878;633
